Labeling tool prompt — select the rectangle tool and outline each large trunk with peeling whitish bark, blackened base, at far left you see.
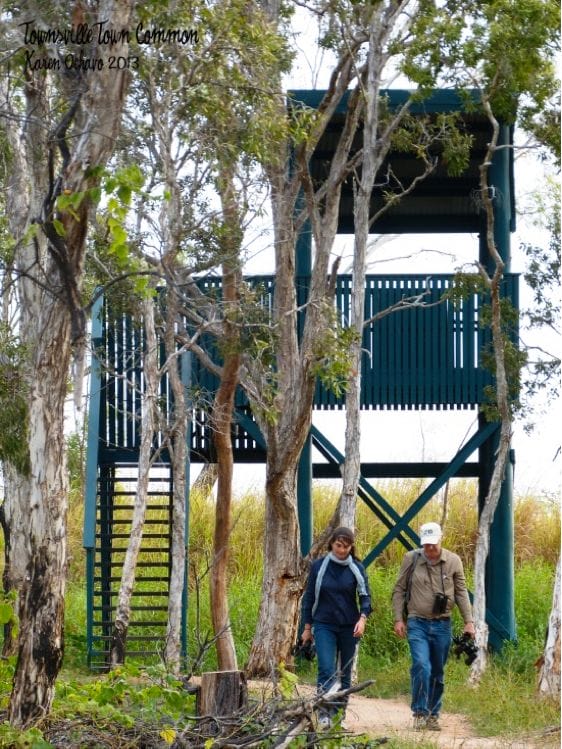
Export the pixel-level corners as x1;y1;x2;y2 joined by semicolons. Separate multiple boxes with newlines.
0;0;132;727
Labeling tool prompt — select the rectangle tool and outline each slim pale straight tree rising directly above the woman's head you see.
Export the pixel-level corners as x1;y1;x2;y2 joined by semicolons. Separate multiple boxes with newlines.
330;3;470;532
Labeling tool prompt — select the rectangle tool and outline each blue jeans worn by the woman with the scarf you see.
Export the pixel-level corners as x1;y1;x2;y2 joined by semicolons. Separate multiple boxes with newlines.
314;622;357;709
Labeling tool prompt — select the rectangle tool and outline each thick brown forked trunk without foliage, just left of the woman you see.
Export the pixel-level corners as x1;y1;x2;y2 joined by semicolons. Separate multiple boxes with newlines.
246;49;358;676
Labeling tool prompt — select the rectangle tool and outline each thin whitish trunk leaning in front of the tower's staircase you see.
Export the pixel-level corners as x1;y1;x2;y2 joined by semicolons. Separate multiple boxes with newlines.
110;297;160;667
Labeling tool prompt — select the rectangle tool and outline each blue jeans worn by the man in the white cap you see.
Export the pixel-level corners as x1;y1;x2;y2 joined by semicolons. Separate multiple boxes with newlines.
408;617;451;716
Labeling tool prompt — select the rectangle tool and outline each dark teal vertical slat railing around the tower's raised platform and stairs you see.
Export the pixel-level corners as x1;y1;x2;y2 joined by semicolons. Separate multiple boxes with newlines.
95;274;517;452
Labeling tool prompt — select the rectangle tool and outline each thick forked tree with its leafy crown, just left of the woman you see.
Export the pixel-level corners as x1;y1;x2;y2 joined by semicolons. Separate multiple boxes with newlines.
238;0;480;674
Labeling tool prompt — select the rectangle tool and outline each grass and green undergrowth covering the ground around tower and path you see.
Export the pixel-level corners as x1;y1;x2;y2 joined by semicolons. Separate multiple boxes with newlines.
0;480;560;749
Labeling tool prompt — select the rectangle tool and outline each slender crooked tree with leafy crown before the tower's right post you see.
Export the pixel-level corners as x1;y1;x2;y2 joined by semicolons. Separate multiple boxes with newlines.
419;0;560;681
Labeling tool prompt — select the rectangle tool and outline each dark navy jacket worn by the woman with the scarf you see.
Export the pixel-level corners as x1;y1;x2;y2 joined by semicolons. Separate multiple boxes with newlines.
302;558;372;625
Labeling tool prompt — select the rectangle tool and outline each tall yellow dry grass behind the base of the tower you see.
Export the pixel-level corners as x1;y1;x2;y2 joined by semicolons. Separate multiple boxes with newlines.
60;479;560;580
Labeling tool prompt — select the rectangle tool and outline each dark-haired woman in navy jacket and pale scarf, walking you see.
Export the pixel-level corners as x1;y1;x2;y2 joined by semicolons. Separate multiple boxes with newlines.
302;528;371;727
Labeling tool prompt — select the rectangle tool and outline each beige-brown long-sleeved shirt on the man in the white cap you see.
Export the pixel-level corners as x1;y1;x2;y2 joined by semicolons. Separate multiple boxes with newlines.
392;549;472;624
